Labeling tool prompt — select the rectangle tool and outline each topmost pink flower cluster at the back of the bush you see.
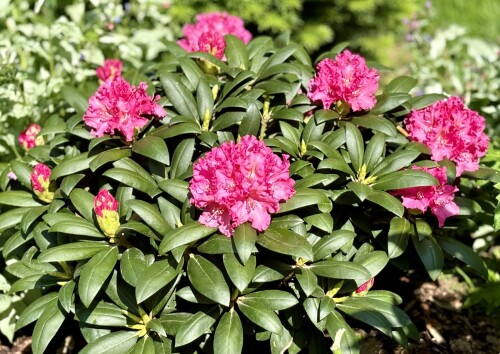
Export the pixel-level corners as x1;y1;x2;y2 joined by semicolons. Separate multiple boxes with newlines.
177;12;252;59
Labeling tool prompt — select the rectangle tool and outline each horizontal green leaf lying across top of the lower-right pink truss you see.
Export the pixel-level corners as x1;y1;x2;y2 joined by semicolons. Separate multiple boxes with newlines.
372;170;438;190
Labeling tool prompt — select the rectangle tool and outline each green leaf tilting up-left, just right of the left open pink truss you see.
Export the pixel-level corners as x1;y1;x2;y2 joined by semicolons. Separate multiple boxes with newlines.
160;73;200;121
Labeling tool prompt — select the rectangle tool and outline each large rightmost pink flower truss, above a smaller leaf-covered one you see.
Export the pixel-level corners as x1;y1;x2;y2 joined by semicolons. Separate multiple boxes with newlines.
405;97;489;176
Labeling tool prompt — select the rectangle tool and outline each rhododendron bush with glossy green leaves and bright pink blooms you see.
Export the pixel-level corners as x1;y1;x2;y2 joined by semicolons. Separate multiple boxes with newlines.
0;11;493;354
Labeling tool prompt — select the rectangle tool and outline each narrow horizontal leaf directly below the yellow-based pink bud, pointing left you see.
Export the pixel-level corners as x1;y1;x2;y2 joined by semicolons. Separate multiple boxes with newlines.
38;242;109;262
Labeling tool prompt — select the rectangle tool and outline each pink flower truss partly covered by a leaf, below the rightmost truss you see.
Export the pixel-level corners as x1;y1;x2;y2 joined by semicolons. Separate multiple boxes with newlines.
393;166;458;227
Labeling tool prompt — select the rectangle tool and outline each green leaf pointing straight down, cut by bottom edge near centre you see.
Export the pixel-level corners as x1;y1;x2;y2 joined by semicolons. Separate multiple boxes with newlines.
214;309;243;354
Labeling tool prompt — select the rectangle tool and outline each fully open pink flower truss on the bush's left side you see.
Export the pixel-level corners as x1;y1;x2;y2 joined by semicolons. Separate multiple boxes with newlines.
83;76;167;141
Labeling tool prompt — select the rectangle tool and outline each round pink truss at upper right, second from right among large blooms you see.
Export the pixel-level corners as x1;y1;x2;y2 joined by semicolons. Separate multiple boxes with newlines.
307;50;379;111
